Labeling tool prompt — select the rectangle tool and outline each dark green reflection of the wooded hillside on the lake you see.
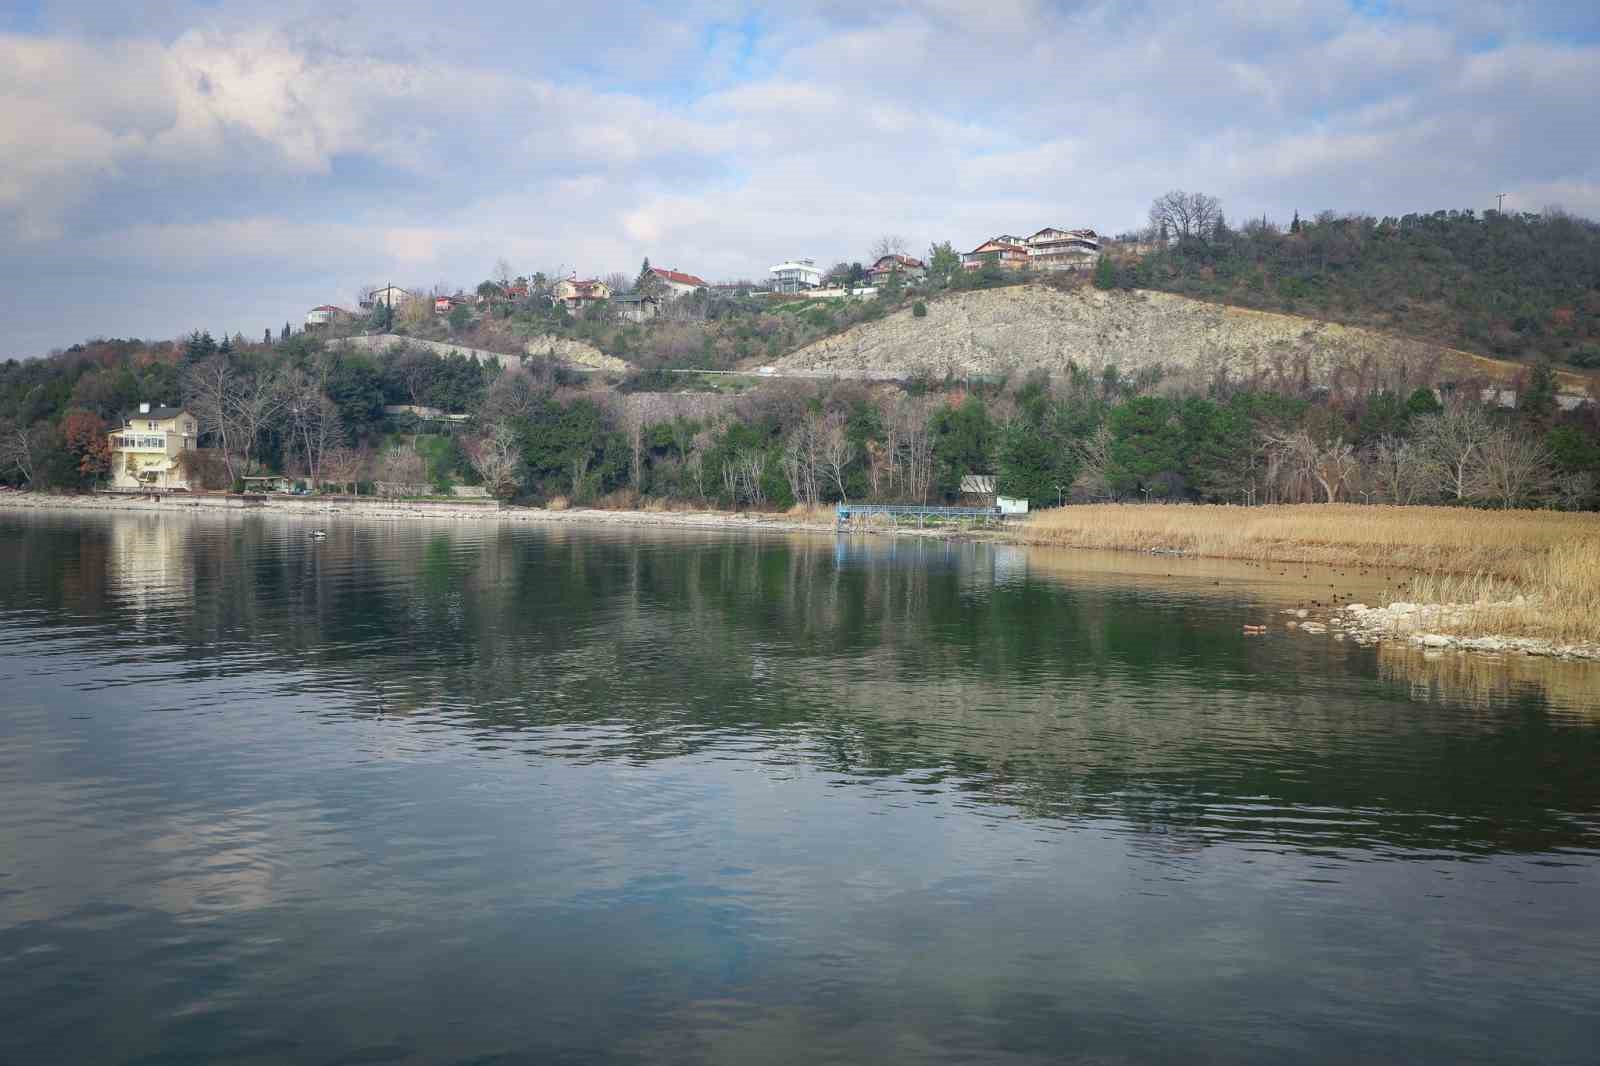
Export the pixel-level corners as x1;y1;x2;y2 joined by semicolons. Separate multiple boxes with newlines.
0;517;1600;853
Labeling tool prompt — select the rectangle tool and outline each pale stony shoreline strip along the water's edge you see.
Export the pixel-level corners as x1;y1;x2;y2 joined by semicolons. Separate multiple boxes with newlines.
0;493;1600;663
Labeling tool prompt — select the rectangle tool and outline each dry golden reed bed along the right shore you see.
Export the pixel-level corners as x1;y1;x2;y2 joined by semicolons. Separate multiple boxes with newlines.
1014;504;1600;642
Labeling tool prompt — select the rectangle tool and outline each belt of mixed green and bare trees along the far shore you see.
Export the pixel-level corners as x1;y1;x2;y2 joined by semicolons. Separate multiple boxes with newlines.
0;326;1600;509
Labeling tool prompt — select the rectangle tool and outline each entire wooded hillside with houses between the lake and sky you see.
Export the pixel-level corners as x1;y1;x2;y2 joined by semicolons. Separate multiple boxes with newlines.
0;201;1600;511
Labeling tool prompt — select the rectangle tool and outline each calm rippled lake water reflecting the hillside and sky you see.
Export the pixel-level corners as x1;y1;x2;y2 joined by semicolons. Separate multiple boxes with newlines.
0;512;1600;1064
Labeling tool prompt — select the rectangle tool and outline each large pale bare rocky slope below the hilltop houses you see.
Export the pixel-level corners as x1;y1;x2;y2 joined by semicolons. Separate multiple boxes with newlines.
774;285;1515;389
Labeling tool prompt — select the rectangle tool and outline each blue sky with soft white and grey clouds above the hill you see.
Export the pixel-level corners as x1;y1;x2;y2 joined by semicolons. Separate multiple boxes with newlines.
0;0;1600;359
